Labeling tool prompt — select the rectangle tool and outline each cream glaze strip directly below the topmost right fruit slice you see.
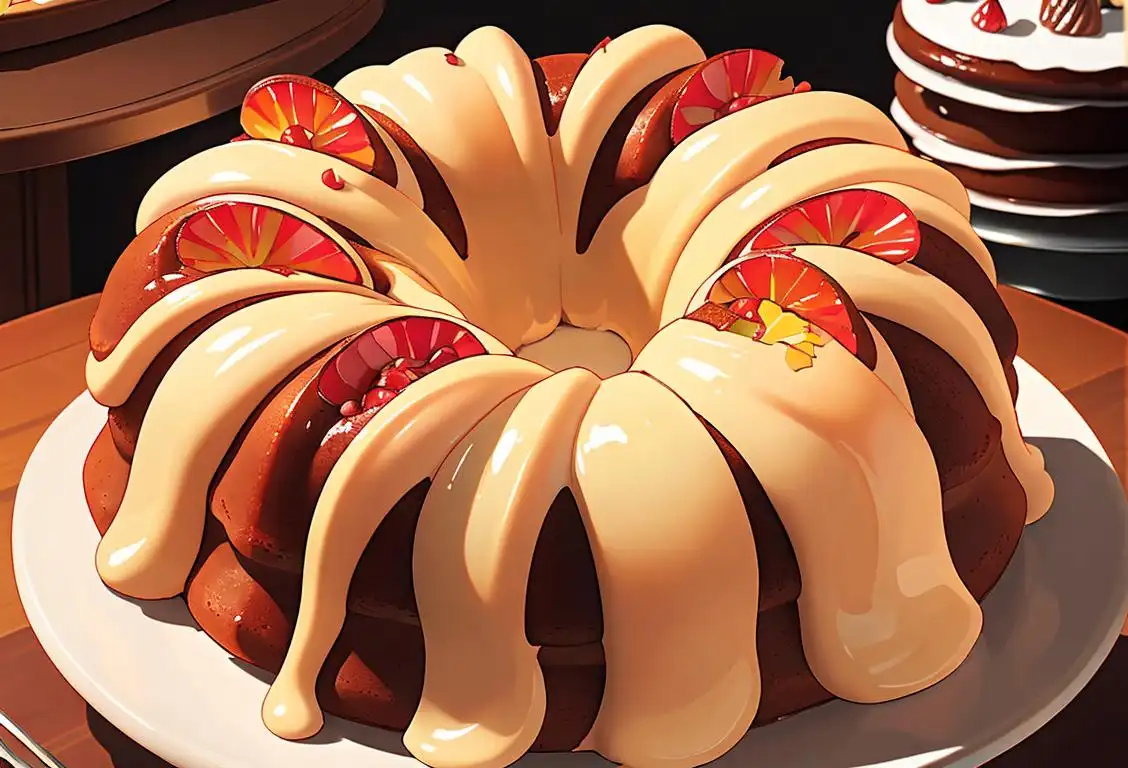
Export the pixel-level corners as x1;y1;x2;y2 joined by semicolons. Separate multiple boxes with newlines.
563;92;906;354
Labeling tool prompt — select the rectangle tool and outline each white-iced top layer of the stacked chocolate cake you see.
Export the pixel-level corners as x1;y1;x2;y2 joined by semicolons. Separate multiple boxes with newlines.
893;0;1128;100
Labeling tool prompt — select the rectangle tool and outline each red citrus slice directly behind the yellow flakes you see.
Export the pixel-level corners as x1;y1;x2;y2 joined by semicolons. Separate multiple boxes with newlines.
708;253;857;354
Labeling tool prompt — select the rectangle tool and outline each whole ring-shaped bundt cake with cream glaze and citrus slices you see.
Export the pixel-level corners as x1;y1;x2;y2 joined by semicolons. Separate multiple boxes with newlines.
85;26;1052;768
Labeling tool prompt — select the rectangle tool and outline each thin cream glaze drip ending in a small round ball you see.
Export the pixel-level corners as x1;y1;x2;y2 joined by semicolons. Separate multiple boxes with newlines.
263;358;548;739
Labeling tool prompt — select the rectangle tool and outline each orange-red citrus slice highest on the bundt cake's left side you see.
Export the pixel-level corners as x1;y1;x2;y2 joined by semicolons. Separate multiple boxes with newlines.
239;74;377;173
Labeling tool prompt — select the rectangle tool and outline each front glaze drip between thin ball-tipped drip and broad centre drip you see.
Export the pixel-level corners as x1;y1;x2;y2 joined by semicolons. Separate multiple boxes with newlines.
404;369;600;768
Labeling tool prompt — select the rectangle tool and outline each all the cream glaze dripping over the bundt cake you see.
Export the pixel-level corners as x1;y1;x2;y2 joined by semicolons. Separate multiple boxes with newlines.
87;21;1052;768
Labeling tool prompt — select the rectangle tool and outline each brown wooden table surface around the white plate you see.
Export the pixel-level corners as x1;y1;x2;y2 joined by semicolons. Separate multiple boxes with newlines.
0;289;1128;768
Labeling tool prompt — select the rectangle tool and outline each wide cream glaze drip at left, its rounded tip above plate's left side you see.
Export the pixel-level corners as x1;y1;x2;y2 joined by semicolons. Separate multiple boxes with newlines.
96;293;403;599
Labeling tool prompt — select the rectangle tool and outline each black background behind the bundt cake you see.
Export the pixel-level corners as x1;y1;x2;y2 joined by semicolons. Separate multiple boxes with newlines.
69;0;1128;327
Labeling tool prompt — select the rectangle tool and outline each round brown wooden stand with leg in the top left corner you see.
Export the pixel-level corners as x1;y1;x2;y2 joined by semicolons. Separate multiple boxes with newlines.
0;0;385;323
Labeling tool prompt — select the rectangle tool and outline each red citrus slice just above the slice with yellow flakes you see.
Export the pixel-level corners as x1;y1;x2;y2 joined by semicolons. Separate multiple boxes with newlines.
733;189;920;264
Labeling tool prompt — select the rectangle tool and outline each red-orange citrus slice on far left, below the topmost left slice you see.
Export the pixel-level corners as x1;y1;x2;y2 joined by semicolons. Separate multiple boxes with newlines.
176;202;368;285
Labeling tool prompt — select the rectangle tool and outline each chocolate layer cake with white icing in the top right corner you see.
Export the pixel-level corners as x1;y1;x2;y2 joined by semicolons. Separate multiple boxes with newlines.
888;0;1128;298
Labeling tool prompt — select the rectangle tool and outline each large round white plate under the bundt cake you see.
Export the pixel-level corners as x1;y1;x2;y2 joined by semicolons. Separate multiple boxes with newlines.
12;361;1128;768
